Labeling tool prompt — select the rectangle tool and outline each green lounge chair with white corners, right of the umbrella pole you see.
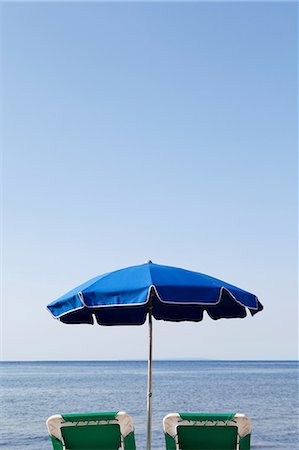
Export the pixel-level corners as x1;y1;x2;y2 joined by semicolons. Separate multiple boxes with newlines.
163;413;251;450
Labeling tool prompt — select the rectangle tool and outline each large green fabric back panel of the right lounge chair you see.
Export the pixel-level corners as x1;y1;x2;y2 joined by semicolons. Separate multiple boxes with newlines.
177;425;238;450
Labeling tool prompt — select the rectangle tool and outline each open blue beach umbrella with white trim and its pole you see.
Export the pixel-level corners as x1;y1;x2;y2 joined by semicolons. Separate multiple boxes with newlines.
48;261;263;450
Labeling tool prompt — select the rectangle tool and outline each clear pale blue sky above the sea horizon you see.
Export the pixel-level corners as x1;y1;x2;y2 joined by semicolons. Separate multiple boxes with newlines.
1;2;298;360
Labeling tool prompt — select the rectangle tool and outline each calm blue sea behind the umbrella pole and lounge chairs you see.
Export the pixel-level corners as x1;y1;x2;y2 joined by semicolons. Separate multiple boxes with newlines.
0;361;299;450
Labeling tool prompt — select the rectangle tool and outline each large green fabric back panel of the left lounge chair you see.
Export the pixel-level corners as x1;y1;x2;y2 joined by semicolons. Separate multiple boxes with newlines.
61;424;121;450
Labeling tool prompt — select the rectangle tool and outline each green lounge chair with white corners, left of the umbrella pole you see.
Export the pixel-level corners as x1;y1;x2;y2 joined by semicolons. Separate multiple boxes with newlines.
47;411;136;450
